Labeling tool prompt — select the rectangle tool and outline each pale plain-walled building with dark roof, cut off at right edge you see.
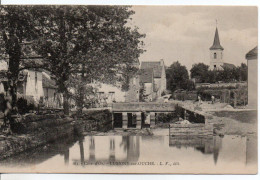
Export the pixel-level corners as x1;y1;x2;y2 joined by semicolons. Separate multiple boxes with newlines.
246;46;258;109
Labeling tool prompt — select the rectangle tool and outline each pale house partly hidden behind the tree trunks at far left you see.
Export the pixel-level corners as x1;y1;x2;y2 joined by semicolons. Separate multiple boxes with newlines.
0;60;62;107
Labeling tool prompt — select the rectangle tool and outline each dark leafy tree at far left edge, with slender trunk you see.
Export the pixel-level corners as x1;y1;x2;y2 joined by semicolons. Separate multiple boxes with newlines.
0;6;35;126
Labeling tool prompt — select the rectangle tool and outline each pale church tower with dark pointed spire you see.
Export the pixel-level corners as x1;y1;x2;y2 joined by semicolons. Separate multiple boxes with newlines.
209;27;224;70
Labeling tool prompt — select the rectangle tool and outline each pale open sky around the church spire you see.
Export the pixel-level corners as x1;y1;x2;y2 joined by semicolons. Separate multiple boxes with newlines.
130;6;258;70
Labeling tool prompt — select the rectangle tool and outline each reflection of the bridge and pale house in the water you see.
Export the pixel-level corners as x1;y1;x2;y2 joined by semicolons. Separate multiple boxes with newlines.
73;136;140;165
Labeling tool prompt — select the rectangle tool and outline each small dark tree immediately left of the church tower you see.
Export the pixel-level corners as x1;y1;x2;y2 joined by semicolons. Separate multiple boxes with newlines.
190;63;209;83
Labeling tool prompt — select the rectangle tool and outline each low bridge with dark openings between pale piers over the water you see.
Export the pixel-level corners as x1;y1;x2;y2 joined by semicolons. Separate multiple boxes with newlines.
110;102;210;129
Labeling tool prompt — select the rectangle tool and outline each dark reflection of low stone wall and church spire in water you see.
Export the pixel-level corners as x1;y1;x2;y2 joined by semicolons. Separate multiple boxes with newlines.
169;136;222;164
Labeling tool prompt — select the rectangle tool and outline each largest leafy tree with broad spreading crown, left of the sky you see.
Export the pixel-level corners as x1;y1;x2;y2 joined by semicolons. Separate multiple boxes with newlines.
31;6;144;114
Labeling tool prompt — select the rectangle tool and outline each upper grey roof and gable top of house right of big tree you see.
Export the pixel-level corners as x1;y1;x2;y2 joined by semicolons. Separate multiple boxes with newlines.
140;61;162;78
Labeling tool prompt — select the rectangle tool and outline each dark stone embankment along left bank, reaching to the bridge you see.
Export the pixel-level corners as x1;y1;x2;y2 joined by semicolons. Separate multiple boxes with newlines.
0;111;112;160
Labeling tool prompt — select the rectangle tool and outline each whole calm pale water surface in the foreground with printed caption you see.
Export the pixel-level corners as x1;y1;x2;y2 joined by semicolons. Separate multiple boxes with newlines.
0;130;257;173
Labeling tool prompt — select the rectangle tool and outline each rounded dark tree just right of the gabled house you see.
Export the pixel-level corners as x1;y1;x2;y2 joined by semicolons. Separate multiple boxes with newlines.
166;61;189;92
